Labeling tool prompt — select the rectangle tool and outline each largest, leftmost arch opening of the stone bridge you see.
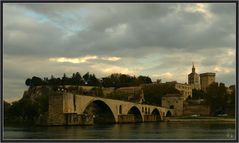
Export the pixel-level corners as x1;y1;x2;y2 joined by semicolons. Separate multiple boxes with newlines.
83;99;116;123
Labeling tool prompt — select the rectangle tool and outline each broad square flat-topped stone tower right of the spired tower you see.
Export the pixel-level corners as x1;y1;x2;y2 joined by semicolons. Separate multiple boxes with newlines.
200;72;216;92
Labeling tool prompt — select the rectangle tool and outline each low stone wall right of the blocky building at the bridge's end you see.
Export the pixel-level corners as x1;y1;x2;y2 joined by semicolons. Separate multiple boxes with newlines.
183;104;210;115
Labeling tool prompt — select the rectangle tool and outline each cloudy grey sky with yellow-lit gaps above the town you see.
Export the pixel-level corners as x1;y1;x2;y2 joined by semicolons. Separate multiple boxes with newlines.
3;3;236;101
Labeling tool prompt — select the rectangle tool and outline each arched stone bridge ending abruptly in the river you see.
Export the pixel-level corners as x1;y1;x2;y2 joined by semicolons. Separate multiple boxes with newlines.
48;93;173;125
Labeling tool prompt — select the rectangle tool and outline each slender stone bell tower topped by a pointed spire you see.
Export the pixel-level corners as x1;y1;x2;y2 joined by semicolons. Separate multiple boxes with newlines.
188;64;201;90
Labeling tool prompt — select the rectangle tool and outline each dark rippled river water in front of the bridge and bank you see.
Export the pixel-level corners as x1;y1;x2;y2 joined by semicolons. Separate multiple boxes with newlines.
3;122;235;139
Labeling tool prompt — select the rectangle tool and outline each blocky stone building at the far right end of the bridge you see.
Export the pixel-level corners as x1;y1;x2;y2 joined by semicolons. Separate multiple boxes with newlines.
161;94;184;116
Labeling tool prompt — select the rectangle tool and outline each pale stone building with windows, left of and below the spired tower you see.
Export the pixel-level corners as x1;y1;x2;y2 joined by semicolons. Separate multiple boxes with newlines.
166;81;192;100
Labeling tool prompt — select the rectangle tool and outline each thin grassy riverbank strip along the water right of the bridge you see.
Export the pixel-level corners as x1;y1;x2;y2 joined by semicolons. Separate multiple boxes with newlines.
165;116;236;123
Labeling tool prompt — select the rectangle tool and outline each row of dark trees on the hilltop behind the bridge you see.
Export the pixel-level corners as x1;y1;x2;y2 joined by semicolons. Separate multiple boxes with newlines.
25;72;152;88
